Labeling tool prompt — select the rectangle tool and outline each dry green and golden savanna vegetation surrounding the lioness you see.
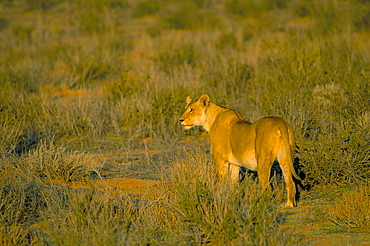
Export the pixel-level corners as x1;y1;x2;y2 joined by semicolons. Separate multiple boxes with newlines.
0;0;370;245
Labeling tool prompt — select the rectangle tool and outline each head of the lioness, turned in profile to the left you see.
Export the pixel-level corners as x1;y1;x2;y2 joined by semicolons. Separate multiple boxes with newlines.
180;95;210;130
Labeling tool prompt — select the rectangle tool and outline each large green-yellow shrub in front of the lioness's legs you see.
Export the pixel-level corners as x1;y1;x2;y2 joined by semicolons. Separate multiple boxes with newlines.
166;153;300;245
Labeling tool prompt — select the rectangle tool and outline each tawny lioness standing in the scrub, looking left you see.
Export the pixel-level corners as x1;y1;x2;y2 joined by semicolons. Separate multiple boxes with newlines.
180;95;300;207
